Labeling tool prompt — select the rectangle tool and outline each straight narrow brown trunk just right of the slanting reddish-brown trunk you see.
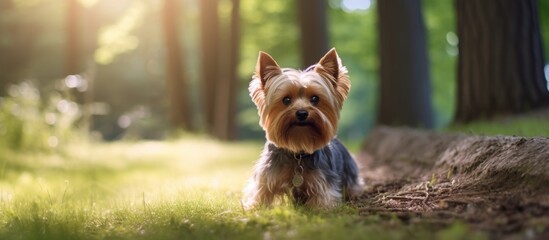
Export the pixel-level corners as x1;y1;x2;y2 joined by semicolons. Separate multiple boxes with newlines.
200;0;219;134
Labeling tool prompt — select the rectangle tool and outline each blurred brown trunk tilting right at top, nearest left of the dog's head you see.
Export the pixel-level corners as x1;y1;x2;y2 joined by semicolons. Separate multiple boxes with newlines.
214;0;240;140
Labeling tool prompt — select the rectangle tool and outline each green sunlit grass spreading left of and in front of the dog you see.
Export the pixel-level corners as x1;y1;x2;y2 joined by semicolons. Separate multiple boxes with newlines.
0;137;488;239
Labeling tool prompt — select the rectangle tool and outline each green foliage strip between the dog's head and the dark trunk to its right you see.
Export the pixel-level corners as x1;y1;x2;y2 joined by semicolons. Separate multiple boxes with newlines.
328;1;379;139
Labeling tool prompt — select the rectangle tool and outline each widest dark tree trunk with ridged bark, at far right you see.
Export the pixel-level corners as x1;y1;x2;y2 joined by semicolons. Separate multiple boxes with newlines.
455;0;549;122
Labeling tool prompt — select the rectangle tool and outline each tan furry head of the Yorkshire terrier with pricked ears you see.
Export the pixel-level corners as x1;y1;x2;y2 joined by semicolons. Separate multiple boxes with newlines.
248;49;351;153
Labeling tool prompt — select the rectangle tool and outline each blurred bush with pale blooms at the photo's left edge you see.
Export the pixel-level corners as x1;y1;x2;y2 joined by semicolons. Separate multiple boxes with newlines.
0;81;82;150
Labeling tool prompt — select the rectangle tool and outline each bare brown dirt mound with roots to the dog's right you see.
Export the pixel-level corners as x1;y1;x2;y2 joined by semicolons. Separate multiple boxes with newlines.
357;128;549;239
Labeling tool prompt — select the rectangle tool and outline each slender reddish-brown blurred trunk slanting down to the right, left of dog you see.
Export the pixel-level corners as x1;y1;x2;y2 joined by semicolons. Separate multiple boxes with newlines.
162;0;195;131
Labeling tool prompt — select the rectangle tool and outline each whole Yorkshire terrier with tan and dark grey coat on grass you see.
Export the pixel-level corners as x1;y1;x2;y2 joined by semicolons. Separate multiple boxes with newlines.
242;48;363;209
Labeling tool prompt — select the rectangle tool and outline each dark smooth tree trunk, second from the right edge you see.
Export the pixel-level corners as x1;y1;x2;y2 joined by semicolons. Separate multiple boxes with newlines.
377;0;434;128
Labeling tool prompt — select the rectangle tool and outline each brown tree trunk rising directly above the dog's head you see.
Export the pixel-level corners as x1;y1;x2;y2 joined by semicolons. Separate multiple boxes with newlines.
296;0;329;68
